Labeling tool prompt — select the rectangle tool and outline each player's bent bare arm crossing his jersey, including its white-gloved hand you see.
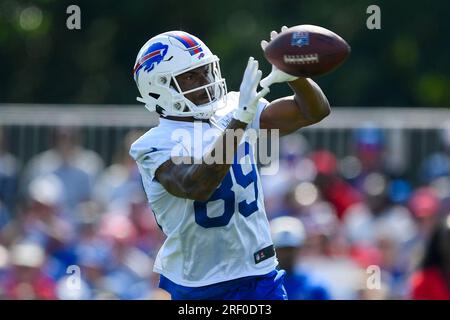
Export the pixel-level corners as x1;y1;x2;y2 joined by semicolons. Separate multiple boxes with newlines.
155;58;269;201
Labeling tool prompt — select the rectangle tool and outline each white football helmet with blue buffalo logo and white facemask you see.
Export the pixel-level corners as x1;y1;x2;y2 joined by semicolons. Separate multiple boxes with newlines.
133;31;227;119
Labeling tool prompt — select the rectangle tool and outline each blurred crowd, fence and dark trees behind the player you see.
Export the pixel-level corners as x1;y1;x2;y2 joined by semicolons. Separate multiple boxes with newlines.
0;0;450;299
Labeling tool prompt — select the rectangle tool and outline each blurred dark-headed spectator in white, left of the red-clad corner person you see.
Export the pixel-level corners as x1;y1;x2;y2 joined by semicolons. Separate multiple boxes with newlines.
343;172;418;298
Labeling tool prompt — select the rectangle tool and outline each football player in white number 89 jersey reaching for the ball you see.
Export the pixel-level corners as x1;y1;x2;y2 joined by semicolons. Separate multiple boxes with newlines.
130;27;330;300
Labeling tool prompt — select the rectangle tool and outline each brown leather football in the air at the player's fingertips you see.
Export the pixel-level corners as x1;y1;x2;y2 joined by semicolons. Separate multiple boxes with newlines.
264;24;350;78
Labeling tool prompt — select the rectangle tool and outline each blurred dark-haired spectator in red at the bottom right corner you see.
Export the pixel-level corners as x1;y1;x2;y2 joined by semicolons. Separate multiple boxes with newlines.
411;215;450;300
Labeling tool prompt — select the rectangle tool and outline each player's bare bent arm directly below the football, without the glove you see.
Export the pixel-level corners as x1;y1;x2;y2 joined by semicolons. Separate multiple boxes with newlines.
260;78;330;135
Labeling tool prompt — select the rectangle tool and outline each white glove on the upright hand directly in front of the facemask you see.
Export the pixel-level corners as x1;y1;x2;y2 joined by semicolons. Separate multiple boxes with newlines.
233;57;270;124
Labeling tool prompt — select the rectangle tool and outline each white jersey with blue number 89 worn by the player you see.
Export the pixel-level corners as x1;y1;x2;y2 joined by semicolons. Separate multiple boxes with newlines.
130;92;278;287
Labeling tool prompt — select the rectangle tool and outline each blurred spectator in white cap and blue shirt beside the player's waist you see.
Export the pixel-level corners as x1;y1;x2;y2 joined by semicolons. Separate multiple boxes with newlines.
270;217;330;300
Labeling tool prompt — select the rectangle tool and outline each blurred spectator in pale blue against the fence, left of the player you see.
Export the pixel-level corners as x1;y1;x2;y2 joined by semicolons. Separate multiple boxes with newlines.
24;127;103;210
